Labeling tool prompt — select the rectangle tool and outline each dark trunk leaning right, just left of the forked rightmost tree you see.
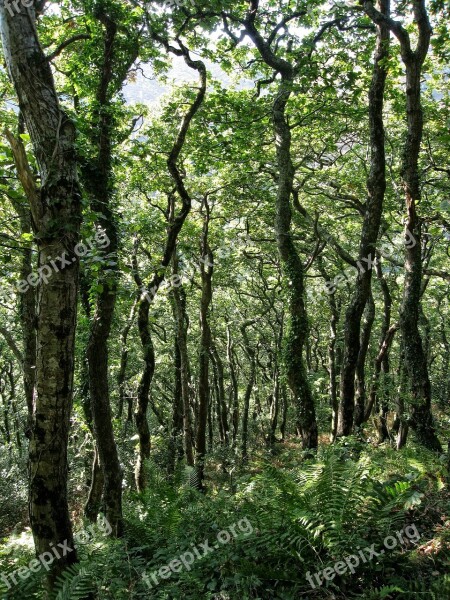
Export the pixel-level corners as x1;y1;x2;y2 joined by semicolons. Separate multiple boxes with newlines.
337;0;390;437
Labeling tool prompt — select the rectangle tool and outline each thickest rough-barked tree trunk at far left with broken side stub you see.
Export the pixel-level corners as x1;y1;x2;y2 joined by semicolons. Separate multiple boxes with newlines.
0;0;81;582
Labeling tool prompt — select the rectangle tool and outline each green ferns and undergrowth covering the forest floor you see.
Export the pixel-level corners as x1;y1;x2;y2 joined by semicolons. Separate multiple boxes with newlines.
0;438;450;600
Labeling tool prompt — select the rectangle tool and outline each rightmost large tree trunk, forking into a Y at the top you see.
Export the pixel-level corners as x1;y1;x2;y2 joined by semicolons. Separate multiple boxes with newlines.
364;0;442;451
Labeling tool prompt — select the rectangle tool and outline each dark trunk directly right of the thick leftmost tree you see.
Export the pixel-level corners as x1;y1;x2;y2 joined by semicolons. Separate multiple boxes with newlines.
83;10;123;536
